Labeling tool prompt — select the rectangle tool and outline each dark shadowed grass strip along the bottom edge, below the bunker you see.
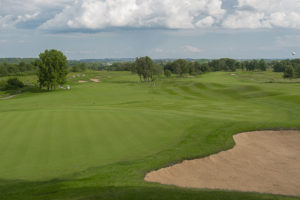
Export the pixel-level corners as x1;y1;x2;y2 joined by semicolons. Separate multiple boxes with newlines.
0;180;298;200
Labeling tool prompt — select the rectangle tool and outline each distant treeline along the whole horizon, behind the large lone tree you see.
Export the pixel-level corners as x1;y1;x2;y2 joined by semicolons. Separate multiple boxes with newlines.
0;57;300;80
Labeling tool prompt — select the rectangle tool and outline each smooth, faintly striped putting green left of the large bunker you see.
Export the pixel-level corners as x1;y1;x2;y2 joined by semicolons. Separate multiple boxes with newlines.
0;110;190;180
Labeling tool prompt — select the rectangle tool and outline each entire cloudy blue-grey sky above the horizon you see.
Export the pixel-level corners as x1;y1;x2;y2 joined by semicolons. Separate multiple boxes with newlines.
0;0;300;59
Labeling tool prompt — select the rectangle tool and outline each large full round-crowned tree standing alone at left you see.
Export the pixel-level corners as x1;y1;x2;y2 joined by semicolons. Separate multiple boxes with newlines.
35;49;68;90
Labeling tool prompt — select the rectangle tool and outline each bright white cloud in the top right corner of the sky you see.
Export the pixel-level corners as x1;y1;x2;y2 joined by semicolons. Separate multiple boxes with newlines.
222;0;300;29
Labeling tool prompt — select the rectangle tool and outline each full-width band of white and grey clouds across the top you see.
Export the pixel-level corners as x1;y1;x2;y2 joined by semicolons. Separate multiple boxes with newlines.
0;0;300;32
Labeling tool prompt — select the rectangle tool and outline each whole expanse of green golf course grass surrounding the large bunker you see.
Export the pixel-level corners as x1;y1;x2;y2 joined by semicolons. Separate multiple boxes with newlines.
0;71;300;200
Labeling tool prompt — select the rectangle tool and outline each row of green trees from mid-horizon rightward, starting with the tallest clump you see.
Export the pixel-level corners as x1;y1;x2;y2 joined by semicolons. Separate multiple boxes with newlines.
128;57;270;81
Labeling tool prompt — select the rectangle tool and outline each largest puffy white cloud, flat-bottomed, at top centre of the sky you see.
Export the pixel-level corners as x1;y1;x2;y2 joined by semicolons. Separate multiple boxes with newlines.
41;0;225;29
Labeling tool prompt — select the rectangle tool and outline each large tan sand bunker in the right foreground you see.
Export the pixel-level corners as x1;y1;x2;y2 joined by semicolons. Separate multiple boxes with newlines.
145;131;300;196
